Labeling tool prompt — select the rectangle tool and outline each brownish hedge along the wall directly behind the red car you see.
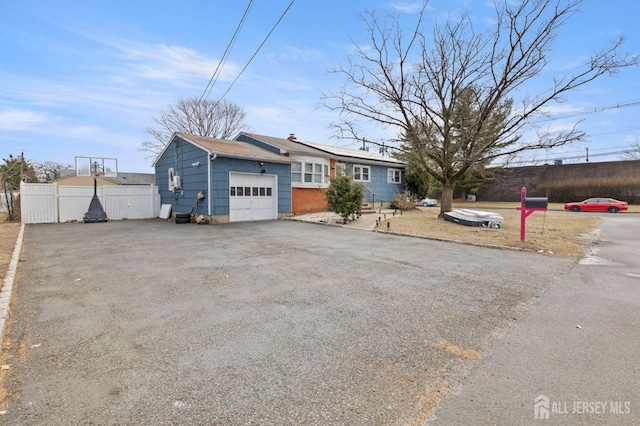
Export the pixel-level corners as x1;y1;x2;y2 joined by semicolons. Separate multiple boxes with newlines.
536;177;640;204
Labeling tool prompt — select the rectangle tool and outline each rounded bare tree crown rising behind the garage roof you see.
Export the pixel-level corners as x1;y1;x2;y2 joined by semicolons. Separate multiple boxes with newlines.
141;98;249;157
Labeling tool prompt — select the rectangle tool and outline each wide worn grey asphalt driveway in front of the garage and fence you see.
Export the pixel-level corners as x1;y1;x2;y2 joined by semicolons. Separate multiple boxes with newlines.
3;220;575;425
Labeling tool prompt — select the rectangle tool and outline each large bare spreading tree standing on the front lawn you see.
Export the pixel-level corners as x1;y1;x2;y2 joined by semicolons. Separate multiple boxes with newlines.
322;0;638;215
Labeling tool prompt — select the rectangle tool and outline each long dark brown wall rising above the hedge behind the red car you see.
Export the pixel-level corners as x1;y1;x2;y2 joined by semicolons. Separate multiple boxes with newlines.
477;160;640;201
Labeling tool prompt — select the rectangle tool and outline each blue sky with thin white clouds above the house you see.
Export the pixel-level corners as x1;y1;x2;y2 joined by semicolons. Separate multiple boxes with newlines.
0;0;640;172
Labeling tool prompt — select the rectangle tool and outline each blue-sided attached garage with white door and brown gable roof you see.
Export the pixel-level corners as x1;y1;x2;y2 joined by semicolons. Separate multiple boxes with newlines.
154;133;292;223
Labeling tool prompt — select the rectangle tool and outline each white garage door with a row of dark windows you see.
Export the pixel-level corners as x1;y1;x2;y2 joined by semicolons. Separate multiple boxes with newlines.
229;173;278;222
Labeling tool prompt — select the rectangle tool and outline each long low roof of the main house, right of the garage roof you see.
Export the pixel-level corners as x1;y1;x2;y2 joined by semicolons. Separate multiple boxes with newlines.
235;132;406;167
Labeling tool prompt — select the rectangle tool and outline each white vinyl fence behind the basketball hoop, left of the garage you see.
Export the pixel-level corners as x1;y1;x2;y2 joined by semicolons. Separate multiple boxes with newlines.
20;183;160;223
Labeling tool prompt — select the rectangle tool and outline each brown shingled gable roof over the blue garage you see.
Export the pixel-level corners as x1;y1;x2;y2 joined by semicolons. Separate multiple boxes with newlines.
154;133;291;166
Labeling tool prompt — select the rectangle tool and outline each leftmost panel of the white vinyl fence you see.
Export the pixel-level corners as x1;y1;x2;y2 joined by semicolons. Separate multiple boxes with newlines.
20;182;58;223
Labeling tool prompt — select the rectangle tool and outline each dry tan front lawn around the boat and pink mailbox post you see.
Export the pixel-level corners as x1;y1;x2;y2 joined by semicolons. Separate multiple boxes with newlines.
376;203;600;257
